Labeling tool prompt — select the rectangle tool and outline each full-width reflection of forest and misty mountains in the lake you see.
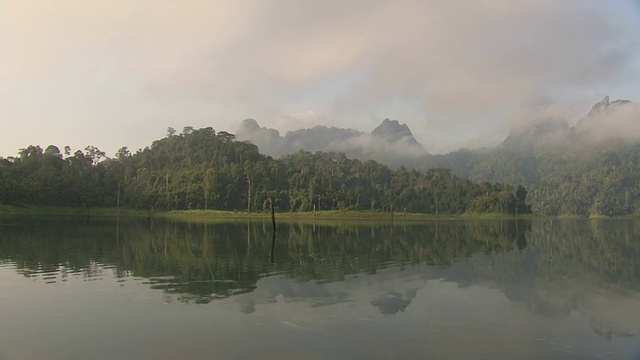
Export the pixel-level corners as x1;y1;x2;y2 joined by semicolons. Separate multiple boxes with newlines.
0;219;640;314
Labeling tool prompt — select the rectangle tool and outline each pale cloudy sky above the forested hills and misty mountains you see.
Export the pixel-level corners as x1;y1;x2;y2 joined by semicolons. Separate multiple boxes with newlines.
0;0;640;156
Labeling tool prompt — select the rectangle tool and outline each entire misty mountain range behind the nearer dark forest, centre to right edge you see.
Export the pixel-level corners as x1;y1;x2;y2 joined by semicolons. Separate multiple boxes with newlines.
238;96;640;217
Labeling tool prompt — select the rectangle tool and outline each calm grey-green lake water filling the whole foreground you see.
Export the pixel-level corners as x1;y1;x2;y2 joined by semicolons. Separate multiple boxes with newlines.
0;218;640;360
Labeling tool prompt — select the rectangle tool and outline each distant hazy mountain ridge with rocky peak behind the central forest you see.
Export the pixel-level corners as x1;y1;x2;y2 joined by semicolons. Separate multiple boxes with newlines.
235;119;427;167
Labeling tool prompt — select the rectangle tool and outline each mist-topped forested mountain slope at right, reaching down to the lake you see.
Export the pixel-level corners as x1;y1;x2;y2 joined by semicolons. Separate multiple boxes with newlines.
422;97;640;217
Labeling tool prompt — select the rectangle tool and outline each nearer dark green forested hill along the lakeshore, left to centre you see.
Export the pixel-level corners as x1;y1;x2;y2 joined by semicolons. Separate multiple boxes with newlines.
0;127;530;215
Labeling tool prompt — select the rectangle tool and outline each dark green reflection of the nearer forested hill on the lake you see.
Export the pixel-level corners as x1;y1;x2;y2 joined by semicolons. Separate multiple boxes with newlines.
0;220;531;302
